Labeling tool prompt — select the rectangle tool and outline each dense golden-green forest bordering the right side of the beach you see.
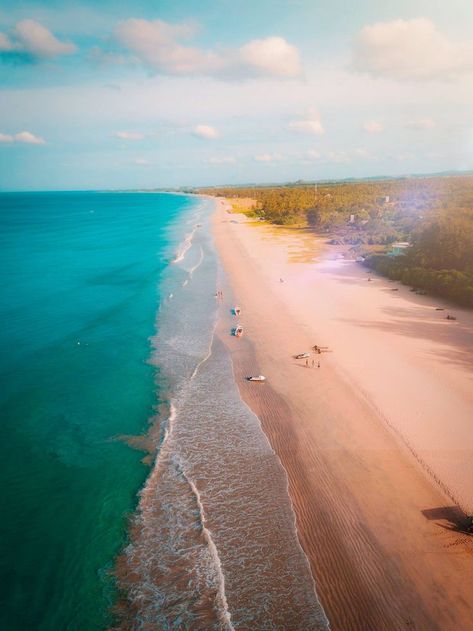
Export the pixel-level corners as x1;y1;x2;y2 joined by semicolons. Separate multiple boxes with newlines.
200;176;473;307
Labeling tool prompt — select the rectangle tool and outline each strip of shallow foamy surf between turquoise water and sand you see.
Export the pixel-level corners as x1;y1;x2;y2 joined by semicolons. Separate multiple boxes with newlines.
117;195;327;631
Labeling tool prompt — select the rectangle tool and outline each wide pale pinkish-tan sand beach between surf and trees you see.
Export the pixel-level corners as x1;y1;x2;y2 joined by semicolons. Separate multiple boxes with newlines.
215;202;473;631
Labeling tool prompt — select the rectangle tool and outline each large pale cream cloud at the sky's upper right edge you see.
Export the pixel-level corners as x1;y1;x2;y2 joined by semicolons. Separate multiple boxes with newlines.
353;18;473;80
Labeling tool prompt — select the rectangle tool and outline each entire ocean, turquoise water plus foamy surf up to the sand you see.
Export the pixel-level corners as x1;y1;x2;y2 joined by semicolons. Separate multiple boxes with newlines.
0;192;326;631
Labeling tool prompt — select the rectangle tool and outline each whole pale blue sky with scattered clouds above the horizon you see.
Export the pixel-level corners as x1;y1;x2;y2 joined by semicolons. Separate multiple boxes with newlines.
0;0;473;190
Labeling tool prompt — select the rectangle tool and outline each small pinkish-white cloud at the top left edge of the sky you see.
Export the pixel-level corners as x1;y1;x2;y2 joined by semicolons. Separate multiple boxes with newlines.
0;20;77;59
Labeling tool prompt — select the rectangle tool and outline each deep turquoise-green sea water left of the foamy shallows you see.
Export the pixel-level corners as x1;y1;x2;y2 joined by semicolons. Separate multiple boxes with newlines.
0;192;202;631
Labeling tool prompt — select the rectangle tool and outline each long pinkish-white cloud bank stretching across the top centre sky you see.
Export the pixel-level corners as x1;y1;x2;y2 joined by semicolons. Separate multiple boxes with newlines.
115;18;301;78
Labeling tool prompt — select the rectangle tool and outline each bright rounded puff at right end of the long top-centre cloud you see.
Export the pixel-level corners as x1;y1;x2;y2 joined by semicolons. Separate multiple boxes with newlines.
239;37;301;77
